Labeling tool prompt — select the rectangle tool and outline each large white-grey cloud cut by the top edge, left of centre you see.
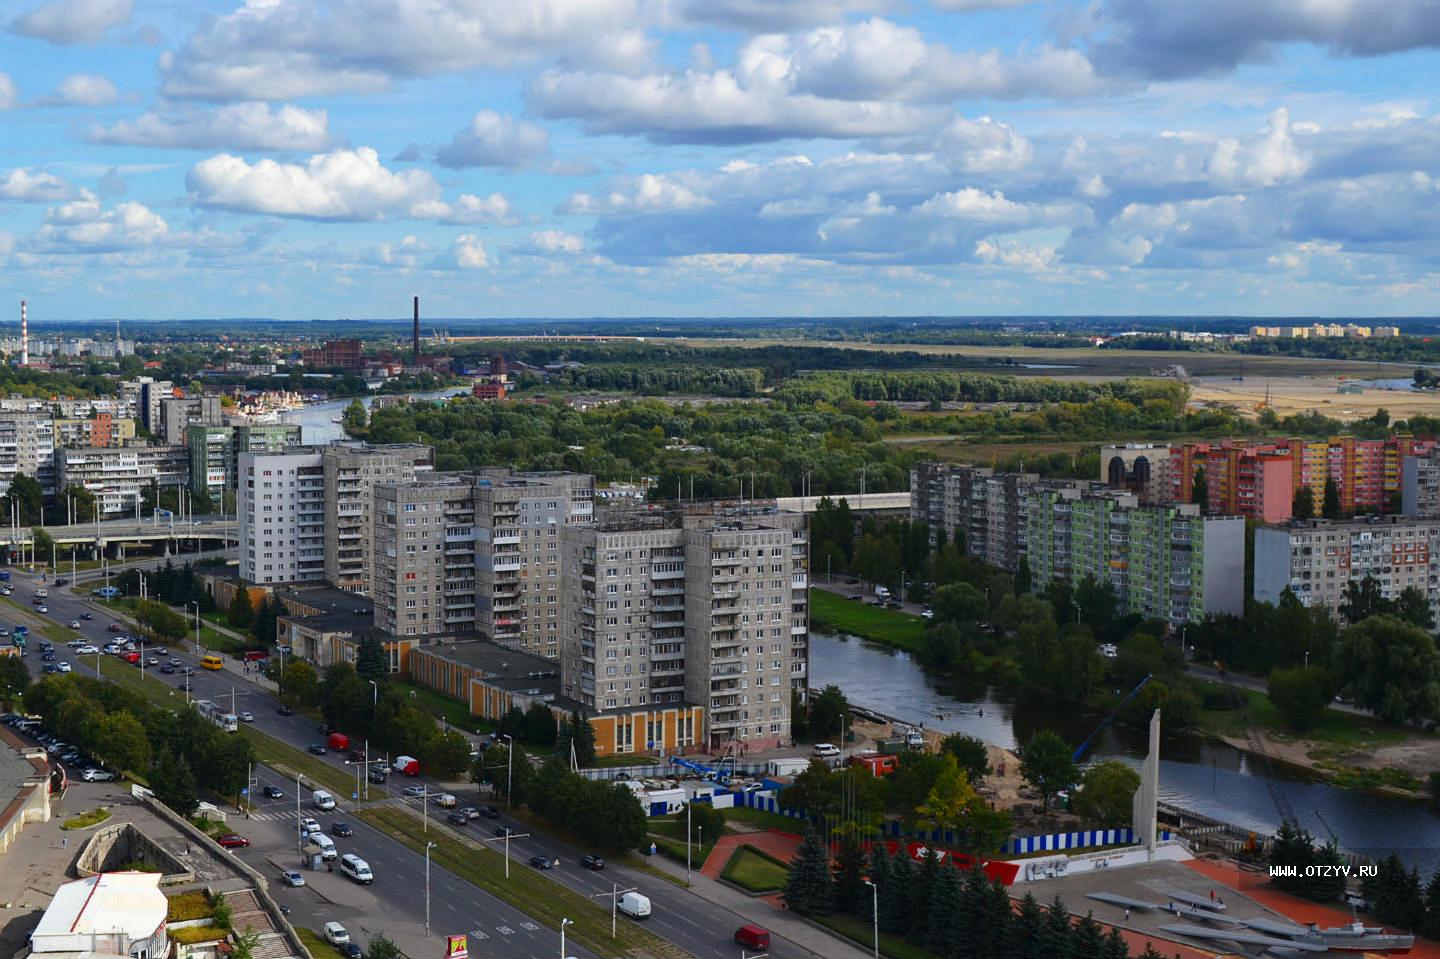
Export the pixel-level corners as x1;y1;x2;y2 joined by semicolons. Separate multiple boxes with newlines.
160;0;647;101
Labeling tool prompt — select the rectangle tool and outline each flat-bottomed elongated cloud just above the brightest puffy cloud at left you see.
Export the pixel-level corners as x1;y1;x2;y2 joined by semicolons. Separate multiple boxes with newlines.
88;101;331;150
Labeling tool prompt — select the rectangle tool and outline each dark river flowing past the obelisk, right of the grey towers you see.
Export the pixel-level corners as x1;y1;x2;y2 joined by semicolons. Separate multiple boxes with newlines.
809;632;1440;863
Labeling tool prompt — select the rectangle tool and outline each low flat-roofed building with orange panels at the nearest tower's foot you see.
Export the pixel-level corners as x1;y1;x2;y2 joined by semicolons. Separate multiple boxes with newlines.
410;641;704;756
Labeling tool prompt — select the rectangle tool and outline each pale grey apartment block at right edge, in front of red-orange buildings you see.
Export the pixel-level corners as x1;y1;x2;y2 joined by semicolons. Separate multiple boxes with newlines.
1254;517;1440;615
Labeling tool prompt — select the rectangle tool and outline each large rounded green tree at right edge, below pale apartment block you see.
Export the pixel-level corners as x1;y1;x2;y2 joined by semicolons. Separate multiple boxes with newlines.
1335;616;1440;723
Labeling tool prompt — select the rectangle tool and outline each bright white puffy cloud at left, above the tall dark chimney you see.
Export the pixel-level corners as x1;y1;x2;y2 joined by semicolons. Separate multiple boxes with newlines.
186;147;441;220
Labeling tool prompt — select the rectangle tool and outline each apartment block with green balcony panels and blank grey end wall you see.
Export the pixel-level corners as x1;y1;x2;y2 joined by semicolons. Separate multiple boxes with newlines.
1025;485;1246;626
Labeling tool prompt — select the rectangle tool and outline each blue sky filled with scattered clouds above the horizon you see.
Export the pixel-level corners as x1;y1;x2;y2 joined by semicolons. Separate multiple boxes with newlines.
0;0;1440;325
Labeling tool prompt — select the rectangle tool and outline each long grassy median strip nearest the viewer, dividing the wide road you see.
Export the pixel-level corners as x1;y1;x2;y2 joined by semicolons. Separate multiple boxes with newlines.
360;806;685;959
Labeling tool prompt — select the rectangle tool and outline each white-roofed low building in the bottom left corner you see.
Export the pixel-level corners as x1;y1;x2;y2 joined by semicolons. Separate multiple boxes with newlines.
30;873;170;959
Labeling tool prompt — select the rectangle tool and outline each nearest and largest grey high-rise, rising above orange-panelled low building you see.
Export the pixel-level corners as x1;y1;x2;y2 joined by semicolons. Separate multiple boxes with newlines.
560;507;809;752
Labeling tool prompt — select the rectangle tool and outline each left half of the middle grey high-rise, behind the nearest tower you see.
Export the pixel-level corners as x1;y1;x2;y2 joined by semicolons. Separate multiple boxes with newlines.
369;474;477;638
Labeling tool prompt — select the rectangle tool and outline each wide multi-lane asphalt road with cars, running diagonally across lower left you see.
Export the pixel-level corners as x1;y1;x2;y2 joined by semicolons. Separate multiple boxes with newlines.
8;570;814;959
